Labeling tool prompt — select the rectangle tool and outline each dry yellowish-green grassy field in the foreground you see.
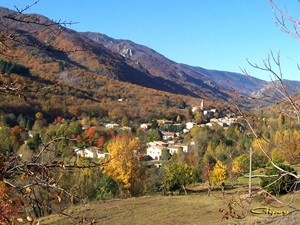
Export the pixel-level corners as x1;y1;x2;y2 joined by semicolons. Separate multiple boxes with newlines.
40;184;300;225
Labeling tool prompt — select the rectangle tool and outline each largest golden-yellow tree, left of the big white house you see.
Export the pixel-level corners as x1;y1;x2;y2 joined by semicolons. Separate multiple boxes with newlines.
103;134;143;196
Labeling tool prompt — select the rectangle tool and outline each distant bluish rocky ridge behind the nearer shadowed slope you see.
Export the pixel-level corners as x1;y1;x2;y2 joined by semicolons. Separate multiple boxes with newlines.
83;32;266;95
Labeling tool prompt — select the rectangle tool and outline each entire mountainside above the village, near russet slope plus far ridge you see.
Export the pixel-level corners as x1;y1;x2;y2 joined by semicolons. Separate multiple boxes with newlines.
0;8;296;119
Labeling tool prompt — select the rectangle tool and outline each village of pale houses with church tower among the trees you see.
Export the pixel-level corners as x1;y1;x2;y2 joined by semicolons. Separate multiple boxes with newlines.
74;100;238;161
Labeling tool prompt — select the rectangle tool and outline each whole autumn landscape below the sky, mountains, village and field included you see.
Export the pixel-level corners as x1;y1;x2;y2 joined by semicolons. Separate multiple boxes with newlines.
0;7;300;225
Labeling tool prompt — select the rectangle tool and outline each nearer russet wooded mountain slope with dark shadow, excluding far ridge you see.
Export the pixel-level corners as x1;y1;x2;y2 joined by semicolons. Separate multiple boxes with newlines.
0;8;232;120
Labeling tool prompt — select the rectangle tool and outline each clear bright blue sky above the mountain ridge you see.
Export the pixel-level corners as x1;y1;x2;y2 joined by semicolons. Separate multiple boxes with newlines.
0;0;300;80
